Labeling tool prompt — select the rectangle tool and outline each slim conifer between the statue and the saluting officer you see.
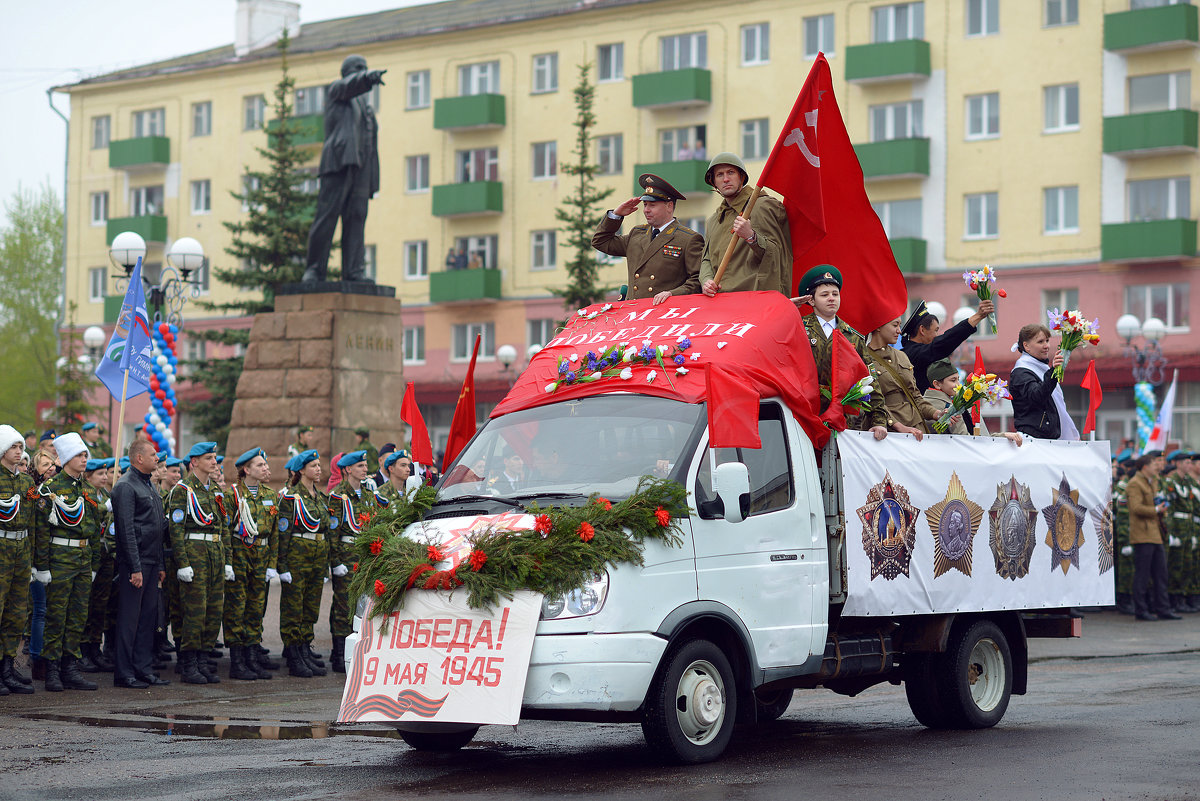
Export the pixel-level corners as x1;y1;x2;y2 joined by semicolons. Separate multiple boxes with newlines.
554;64;613;311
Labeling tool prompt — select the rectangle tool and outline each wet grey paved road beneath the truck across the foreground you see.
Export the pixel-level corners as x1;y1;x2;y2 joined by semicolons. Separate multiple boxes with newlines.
0;613;1200;801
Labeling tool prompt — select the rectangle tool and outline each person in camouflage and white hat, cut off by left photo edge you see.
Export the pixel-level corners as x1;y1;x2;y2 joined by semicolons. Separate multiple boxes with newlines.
0;426;37;695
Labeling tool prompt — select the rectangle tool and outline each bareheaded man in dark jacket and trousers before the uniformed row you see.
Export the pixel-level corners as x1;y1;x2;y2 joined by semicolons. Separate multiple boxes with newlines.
112;440;170;689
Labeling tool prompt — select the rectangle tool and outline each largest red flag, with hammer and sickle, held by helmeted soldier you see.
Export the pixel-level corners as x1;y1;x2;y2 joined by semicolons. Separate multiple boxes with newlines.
758;53;908;335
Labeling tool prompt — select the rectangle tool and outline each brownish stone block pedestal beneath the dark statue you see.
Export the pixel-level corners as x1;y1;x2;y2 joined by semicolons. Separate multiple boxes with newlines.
227;282;404;465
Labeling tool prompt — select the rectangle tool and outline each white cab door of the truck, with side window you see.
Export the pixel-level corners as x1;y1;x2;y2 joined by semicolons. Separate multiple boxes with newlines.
692;401;828;668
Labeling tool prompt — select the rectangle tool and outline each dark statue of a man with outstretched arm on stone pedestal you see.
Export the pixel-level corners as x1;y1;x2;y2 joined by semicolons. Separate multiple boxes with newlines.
301;55;388;283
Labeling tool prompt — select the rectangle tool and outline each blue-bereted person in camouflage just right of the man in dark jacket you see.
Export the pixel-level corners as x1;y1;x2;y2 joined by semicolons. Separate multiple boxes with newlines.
166;442;234;685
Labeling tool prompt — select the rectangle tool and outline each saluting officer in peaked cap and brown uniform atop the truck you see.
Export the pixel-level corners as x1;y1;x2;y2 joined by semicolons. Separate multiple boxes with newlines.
592;173;704;306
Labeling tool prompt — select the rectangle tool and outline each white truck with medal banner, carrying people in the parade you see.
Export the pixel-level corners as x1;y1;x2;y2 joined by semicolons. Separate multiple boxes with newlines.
346;292;1112;763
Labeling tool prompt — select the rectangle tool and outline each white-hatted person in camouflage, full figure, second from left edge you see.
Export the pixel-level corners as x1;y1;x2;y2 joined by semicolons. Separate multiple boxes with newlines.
34;433;103;692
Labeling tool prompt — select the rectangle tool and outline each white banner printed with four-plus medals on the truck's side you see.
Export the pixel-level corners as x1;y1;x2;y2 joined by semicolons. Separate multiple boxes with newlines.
838;432;1114;616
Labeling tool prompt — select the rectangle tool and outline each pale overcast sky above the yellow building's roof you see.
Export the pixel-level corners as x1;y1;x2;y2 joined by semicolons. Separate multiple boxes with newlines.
0;0;430;212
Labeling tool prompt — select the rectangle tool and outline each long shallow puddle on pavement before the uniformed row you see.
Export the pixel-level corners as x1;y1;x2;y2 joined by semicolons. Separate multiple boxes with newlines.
22;713;400;740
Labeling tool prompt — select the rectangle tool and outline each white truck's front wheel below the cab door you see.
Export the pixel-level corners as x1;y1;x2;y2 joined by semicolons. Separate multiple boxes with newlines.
642;639;738;764
